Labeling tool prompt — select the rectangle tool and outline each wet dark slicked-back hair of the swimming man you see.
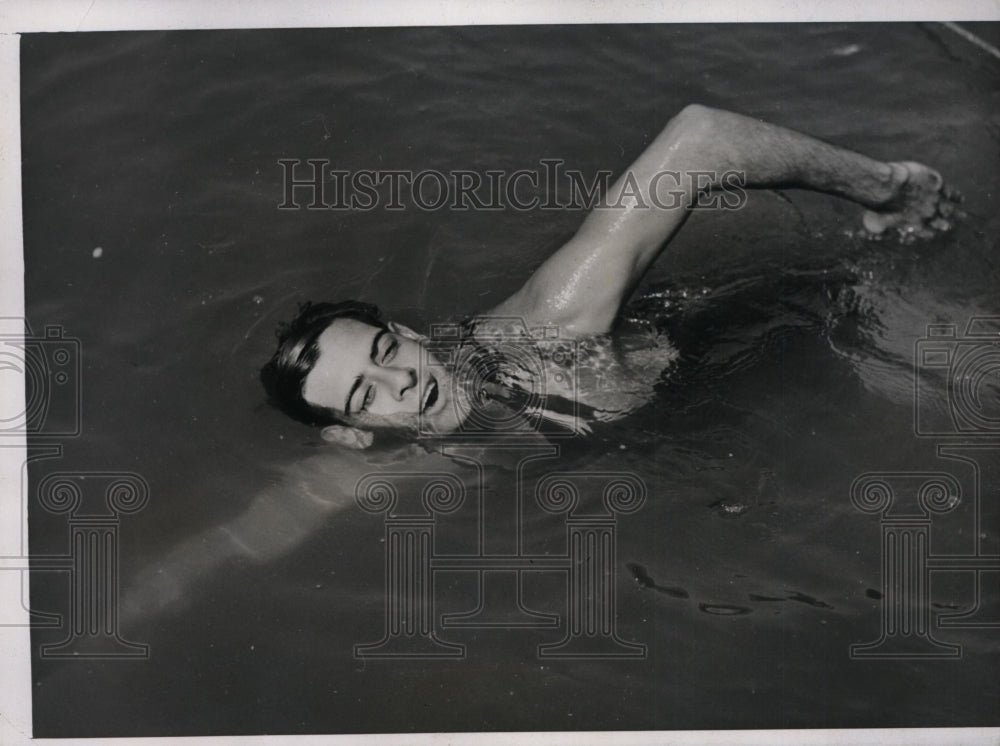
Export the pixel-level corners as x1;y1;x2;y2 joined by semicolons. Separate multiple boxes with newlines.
260;300;386;426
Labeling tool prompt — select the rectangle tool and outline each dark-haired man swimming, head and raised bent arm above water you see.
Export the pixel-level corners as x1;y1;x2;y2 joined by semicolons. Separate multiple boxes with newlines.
261;105;951;448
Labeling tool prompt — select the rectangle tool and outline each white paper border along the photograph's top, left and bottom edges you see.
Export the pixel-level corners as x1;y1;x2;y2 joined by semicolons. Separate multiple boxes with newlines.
0;0;1000;745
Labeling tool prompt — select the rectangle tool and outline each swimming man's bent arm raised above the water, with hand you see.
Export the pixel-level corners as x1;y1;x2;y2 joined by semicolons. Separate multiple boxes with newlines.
494;105;941;334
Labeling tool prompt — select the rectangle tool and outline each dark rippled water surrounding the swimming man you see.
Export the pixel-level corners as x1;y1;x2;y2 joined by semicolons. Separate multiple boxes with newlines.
22;24;1000;736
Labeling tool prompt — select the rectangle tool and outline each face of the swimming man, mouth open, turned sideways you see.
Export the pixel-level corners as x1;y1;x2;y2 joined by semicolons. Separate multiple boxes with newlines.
302;319;459;432
